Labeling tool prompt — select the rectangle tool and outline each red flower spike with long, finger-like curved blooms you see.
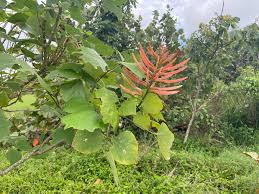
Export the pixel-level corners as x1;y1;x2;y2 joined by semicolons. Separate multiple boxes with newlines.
120;46;190;95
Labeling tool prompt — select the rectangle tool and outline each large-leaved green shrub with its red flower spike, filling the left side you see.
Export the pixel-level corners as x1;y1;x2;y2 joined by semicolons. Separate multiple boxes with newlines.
0;0;189;183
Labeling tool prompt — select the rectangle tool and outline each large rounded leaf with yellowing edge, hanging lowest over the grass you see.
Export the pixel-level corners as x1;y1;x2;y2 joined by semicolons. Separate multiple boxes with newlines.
110;131;138;165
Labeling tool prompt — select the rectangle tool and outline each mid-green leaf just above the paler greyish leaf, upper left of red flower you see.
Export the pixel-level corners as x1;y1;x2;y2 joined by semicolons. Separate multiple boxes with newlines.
87;36;113;57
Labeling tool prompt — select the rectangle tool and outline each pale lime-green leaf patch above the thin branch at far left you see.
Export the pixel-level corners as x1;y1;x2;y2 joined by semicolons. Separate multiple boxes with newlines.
8;94;36;111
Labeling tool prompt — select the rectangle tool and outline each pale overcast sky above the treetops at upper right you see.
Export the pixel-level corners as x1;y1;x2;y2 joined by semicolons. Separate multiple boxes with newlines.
135;0;259;35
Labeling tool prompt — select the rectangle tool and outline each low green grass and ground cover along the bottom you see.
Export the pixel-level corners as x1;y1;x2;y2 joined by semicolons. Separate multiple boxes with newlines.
0;143;259;194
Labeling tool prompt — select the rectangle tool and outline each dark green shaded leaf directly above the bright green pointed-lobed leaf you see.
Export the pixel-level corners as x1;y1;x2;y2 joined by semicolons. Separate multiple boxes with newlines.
60;80;86;101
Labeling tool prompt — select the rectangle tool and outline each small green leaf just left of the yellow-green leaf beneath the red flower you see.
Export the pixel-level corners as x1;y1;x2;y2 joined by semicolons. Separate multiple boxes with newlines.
119;98;137;116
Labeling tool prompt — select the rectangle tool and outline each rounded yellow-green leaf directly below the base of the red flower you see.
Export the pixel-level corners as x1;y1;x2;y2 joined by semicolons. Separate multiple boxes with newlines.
141;93;163;114
